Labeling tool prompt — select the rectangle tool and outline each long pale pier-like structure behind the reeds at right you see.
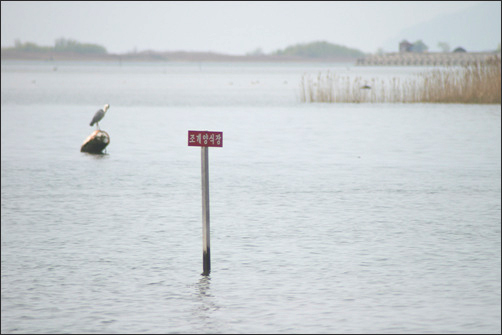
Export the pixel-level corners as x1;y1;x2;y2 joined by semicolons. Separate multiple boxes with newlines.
356;52;500;66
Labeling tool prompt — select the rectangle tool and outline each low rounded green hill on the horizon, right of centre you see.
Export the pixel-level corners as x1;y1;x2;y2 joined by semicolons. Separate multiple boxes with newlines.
272;41;364;58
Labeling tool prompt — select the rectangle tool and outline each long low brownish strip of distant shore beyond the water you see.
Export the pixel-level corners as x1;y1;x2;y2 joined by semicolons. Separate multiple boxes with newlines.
1;50;357;64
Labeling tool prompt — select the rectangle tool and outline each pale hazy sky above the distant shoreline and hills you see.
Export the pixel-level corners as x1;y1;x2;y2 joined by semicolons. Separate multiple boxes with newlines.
1;1;486;55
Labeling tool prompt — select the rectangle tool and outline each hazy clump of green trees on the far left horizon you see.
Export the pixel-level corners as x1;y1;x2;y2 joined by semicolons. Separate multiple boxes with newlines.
2;38;107;55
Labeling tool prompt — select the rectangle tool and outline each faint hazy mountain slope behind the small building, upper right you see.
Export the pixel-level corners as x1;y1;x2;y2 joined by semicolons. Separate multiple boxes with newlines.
382;1;501;52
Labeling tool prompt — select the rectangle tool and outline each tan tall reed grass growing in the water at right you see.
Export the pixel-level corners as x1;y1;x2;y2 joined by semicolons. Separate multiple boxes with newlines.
300;56;501;104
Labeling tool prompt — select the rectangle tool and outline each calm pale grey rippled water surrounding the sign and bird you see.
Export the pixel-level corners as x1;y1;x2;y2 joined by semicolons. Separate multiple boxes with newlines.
1;62;501;333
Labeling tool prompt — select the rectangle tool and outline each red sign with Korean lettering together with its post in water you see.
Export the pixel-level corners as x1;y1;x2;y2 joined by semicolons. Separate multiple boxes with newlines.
188;130;223;276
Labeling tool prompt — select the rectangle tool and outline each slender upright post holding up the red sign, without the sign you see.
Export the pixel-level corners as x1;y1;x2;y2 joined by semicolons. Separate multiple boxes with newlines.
201;147;211;276
